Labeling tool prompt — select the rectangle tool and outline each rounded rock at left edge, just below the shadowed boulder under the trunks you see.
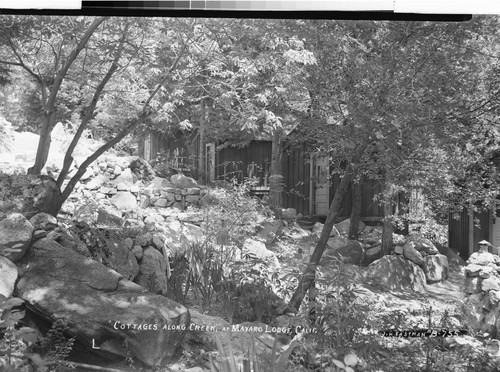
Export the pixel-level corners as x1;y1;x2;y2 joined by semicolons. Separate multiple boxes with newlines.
0;213;35;262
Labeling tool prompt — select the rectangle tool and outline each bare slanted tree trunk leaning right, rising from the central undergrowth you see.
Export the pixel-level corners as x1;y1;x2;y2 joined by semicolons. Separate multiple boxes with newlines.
289;165;352;310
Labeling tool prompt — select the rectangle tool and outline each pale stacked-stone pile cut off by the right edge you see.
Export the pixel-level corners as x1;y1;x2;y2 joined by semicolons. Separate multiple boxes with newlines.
464;252;500;338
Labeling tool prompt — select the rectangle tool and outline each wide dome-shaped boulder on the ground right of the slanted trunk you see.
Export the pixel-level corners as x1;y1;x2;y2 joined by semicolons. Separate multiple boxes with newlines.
366;255;426;292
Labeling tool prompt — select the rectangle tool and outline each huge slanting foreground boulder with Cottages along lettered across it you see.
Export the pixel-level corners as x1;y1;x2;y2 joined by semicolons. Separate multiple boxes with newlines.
17;238;190;366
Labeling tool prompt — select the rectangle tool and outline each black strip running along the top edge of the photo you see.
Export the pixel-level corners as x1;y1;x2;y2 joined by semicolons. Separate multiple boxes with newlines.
0;0;472;22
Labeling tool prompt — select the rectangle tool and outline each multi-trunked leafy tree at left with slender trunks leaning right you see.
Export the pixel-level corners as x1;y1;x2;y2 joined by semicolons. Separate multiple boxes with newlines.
0;17;221;213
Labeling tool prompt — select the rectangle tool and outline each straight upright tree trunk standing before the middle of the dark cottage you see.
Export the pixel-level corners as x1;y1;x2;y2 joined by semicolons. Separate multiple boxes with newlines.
269;129;283;212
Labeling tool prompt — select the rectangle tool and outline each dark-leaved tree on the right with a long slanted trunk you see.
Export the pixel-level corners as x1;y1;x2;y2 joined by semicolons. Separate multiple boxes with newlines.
290;16;500;308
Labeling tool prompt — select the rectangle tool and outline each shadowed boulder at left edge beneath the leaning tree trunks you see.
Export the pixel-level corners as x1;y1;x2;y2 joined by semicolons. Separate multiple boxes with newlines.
0;174;61;219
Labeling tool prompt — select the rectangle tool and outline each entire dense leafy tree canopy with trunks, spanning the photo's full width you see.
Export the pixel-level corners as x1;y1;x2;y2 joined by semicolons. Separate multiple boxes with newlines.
0;16;500;306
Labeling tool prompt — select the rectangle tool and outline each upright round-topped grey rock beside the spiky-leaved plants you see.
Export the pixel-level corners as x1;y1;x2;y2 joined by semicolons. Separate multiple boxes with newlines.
136;247;167;295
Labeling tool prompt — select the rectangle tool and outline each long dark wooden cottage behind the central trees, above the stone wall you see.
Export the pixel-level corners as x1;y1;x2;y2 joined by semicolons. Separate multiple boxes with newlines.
140;131;383;223
